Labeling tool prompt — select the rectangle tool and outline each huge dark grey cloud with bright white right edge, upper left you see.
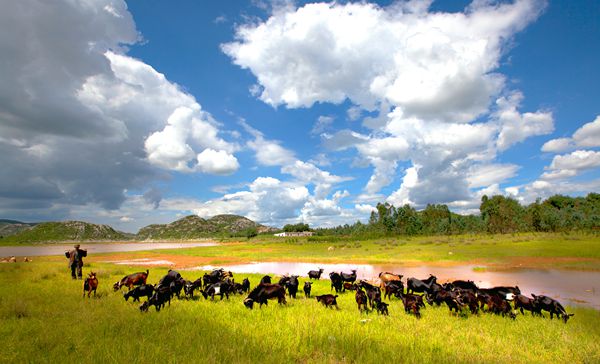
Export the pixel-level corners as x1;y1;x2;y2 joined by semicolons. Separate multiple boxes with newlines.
0;0;237;221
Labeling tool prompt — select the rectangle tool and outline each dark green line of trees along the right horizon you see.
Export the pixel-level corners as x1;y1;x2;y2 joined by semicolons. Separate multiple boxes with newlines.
315;193;600;237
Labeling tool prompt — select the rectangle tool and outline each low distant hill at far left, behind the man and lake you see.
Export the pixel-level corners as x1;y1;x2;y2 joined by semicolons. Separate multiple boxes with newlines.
0;221;132;243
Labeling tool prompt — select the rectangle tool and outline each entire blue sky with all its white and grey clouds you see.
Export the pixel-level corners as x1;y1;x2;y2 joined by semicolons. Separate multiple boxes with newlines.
0;0;600;232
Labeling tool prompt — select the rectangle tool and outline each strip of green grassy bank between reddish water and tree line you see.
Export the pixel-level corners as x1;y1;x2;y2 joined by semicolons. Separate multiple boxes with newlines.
89;234;600;270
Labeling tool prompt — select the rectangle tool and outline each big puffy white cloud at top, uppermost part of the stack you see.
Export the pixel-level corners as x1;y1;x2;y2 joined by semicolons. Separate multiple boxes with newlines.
222;1;544;121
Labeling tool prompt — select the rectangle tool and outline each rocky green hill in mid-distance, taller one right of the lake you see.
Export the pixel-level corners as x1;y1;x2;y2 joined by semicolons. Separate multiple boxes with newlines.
137;215;274;240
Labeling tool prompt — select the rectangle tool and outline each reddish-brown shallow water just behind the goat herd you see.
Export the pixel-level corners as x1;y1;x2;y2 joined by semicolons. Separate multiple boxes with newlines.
189;262;600;309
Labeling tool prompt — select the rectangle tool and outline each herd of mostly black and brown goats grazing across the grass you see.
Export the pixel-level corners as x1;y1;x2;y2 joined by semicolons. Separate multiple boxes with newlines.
92;268;573;323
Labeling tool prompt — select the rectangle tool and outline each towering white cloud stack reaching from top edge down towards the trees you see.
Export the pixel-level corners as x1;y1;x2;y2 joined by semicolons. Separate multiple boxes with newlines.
222;0;554;210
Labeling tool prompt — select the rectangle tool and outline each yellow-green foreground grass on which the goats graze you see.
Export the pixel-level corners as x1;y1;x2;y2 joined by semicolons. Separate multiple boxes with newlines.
0;258;600;363
